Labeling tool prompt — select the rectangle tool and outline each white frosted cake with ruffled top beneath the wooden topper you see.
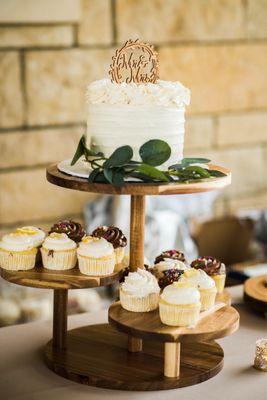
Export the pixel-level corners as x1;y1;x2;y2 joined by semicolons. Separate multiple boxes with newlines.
86;79;190;165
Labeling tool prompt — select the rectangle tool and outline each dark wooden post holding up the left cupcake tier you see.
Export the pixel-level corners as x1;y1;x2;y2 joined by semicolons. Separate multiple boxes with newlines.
53;289;68;349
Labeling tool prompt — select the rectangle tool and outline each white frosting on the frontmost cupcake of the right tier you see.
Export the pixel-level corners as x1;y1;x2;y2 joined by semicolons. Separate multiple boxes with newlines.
160;282;200;304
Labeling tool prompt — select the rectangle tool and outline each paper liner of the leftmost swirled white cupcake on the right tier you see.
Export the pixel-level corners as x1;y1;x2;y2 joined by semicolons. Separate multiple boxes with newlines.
120;289;159;312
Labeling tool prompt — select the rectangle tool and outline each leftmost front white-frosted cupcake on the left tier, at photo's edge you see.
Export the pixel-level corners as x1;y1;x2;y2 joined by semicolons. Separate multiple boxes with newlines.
0;232;37;271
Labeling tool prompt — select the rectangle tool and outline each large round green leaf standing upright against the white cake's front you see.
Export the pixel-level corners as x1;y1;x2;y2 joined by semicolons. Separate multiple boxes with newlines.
139;139;171;167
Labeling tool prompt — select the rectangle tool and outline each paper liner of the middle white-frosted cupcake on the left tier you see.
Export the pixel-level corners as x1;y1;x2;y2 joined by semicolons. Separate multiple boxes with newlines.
41;247;77;271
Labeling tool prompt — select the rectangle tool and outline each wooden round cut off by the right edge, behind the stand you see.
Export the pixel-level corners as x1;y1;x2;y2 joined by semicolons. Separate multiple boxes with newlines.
244;275;267;317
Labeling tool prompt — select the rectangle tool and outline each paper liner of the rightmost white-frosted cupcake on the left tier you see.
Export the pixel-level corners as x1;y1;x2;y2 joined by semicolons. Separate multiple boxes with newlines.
78;253;115;276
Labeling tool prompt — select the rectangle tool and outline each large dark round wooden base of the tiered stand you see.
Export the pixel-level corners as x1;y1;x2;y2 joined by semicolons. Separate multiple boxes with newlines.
45;324;223;390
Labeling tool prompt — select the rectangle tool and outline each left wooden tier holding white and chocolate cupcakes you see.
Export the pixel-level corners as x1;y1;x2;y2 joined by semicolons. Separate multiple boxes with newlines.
0;266;121;289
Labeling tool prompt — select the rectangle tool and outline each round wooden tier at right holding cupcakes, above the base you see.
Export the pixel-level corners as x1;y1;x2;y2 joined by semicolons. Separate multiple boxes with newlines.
109;294;239;343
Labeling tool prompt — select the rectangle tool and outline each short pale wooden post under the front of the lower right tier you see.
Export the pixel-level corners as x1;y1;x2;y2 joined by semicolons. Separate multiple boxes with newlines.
164;342;180;378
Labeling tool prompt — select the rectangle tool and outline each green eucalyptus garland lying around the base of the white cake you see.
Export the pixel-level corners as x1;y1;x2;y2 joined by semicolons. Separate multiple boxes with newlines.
71;136;226;186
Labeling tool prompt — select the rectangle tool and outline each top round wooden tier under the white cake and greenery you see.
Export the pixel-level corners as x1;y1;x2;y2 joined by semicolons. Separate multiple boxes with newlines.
46;164;231;196
